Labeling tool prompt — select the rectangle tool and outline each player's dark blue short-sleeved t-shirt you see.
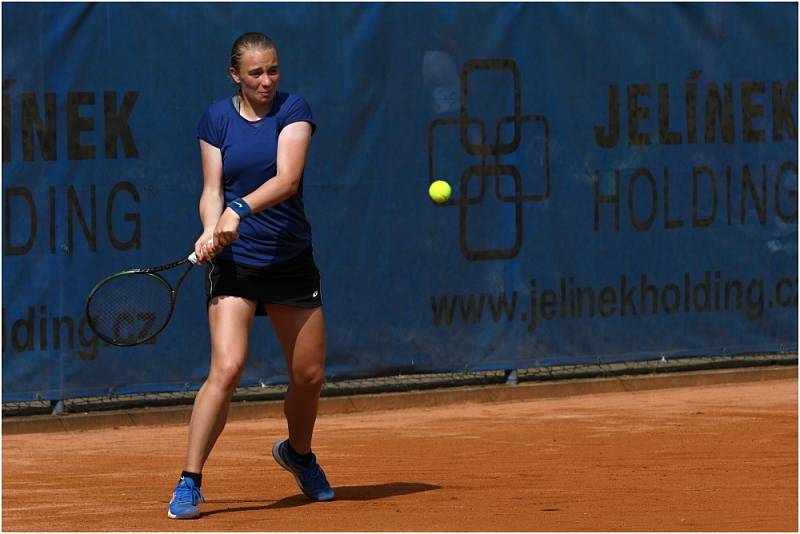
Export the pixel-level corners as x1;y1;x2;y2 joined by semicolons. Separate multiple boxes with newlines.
197;93;316;267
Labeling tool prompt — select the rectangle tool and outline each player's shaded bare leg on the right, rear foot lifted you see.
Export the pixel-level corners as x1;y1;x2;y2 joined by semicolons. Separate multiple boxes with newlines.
266;304;325;454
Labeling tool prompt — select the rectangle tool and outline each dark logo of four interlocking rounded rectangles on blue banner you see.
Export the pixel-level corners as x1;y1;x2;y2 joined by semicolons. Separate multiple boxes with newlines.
428;59;551;261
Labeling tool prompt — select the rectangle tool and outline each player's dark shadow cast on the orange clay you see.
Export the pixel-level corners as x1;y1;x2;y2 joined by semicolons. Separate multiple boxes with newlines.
200;482;442;517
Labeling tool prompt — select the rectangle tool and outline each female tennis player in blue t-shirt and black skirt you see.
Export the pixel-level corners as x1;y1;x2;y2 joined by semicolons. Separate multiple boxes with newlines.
168;33;333;519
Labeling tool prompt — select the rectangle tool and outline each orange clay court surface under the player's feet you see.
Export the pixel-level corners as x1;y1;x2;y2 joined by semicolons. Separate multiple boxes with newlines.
2;379;798;531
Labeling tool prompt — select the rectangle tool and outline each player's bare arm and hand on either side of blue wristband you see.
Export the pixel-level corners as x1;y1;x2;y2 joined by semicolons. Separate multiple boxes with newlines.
214;121;311;247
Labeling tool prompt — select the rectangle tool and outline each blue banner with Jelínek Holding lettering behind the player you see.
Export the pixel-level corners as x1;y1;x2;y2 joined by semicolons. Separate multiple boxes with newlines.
2;2;798;400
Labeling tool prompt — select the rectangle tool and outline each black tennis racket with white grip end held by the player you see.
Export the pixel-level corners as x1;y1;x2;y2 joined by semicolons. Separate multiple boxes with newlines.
85;252;197;347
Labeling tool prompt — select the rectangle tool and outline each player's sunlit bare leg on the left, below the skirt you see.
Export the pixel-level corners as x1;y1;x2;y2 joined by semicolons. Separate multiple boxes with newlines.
184;297;256;473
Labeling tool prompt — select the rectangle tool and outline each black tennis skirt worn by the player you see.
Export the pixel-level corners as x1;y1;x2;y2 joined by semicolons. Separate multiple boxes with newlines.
206;247;322;315
